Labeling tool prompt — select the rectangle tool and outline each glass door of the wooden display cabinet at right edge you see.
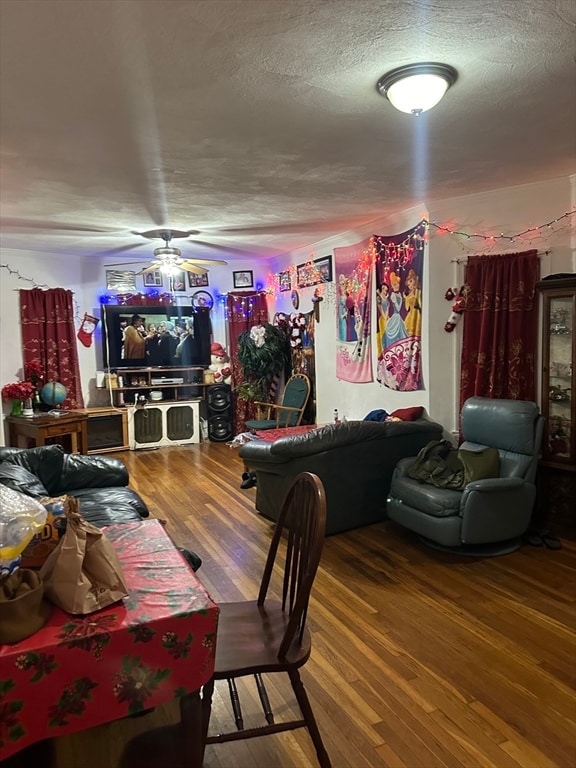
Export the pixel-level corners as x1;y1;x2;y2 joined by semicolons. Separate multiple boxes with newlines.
539;278;576;469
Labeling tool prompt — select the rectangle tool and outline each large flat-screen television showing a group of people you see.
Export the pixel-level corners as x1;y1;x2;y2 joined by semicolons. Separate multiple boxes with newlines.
101;304;212;370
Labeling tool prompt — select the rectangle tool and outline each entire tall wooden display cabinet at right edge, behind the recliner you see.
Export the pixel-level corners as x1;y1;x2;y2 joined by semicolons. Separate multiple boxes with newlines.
534;275;576;539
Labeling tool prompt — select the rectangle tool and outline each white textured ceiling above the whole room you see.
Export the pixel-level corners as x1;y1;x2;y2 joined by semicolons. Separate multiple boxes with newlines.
0;0;576;261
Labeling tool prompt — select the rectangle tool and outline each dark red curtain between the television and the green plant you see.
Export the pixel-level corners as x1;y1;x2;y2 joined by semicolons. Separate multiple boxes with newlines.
226;291;268;434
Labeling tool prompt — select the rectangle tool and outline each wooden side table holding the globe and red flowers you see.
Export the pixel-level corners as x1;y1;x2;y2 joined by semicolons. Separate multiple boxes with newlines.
6;411;88;454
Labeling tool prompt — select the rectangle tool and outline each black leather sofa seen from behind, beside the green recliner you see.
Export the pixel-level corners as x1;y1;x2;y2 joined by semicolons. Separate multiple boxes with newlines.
239;417;443;535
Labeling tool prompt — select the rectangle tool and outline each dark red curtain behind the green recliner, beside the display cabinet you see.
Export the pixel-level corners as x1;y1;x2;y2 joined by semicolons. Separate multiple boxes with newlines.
460;250;538;408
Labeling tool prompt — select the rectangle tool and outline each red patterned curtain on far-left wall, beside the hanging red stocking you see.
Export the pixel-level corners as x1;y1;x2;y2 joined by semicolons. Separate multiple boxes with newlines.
20;288;84;408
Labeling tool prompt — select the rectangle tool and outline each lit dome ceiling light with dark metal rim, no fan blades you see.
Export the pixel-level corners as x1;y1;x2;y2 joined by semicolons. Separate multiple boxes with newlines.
377;62;458;115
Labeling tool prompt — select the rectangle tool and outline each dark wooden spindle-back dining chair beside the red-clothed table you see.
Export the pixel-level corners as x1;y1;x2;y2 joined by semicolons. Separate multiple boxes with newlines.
203;472;330;768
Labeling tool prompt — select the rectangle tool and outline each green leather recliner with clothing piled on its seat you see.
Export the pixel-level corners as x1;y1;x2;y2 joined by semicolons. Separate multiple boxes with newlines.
386;397;544;556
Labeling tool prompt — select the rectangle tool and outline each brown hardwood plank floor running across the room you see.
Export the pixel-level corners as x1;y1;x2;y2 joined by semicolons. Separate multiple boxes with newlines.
40;443;576;768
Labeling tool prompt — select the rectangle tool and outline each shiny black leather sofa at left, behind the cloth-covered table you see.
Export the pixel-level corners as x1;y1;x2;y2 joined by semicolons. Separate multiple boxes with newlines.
0;445;149;528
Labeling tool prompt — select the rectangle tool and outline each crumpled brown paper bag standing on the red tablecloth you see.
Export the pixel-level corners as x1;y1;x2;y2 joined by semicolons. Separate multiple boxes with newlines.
40;497;128;613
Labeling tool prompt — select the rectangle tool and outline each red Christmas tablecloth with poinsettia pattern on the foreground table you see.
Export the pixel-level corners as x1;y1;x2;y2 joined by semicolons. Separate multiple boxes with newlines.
0;520;219;759
